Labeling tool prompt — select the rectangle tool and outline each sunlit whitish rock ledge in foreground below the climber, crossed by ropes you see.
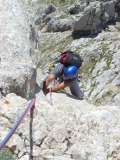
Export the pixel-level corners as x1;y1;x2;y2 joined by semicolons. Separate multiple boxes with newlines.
0;93;120;160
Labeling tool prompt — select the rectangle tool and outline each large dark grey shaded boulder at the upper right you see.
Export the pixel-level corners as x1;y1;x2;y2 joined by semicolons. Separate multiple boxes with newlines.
73;1;115;35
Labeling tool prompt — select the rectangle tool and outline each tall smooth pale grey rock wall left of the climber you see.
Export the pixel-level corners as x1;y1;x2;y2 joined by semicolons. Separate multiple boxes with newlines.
0;0;35;97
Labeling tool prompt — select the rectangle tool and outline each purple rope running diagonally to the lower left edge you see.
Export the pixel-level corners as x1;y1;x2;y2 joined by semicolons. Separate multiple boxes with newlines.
0;98;35;150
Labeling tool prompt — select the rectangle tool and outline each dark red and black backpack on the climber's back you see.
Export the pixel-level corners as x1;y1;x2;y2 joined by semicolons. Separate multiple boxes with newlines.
60;51;83;68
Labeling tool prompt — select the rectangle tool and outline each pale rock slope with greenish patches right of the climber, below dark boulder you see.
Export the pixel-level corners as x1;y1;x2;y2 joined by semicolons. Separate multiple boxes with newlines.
70;26;120;105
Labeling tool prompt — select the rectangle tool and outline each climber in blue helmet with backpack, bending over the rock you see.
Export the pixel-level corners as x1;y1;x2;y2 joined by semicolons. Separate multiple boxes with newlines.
42;51;84;100
